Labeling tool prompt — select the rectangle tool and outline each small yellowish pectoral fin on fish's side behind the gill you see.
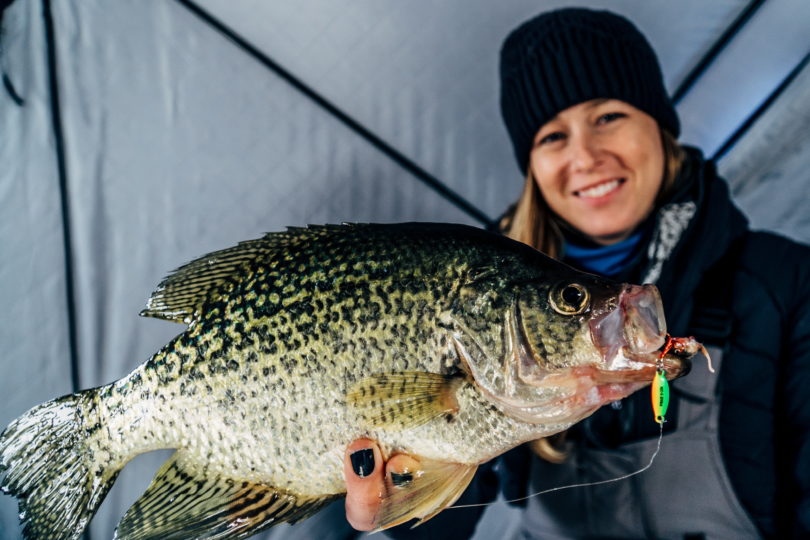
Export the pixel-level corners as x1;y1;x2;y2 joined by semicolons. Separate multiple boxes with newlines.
346;371;461;429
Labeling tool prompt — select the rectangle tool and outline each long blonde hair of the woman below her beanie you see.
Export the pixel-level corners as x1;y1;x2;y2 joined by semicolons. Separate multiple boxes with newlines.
499;129;686;463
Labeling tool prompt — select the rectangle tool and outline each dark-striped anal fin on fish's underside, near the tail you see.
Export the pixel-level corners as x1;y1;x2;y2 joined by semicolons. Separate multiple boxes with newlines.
114;451;338;540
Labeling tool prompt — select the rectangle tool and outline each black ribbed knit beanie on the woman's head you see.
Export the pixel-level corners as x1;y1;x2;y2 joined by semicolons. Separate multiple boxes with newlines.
501;8;680;174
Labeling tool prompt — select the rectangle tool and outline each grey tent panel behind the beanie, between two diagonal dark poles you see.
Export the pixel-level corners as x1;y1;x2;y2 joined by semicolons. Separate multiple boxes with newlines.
197;0;747;220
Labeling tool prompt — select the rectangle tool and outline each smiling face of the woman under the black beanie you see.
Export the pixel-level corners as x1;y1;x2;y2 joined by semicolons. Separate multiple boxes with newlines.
530;99;664;245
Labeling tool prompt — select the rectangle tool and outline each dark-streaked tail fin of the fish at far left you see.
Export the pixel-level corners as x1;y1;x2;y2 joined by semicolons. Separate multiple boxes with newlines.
0;389;123;540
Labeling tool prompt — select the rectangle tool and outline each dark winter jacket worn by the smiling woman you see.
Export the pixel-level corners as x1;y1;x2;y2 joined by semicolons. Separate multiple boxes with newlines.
382;149;810;539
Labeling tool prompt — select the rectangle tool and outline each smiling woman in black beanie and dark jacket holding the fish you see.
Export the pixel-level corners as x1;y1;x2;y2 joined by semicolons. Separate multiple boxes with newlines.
345;9;810;538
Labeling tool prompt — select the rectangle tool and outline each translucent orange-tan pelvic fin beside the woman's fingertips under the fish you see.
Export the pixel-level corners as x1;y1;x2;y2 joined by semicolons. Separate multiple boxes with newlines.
376;454;478;530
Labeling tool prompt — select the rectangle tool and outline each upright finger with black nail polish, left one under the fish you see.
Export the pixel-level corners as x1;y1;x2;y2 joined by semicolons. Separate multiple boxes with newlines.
343;439;385;531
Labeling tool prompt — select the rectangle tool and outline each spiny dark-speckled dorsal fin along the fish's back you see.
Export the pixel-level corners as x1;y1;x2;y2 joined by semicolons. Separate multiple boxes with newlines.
140;224;354;324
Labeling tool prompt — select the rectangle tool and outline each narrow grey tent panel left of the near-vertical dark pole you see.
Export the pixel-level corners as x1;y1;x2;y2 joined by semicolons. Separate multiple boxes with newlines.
0;3;71;539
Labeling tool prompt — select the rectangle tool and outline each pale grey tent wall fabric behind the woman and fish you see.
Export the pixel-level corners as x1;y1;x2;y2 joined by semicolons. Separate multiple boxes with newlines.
0;0;810;540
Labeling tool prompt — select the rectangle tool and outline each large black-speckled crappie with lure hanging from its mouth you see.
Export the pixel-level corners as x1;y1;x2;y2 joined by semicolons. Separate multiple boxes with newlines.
0;223;698;540
